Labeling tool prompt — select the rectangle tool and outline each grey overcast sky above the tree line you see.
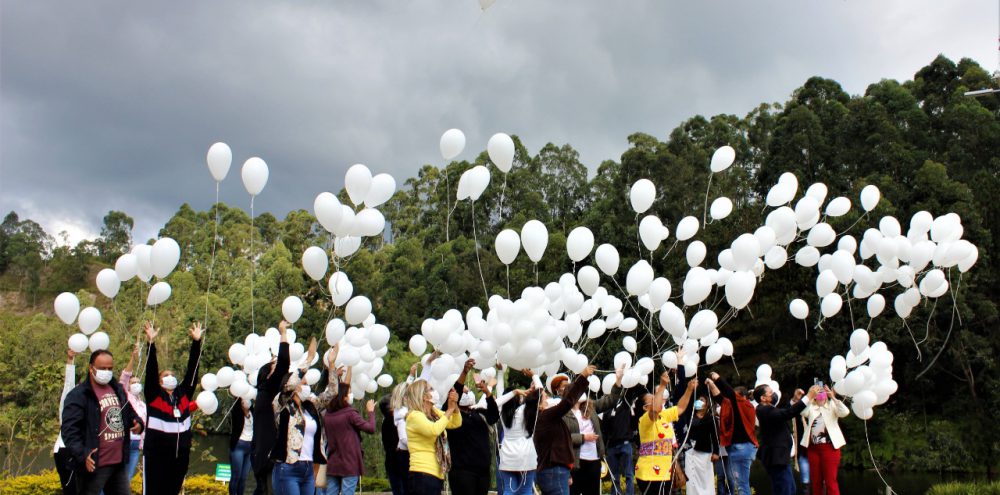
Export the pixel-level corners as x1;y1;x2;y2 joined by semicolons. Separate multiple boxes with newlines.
0;0;998;242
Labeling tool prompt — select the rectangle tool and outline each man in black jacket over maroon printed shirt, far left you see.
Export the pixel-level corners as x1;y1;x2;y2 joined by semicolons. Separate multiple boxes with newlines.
61;350;144;495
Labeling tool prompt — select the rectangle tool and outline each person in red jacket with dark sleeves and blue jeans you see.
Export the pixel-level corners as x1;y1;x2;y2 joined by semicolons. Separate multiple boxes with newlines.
705;372;757;495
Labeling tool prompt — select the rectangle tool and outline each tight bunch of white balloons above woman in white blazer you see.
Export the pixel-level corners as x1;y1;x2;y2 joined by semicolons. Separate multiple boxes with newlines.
830;328;899;419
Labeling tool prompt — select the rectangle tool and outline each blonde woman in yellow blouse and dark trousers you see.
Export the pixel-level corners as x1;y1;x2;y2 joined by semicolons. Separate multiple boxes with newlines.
405;380;462;495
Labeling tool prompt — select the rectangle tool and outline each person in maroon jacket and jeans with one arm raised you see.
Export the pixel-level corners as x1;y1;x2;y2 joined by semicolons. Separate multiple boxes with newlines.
323;369;375;495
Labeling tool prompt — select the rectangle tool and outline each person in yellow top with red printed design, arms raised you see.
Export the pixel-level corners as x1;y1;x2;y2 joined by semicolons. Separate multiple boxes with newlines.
635;372;697;495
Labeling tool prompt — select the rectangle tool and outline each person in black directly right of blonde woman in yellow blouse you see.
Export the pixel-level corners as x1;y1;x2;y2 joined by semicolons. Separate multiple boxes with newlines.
448;359;500;495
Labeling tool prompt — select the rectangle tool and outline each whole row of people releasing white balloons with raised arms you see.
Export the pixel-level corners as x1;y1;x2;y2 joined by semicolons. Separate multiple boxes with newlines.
54;322;849;495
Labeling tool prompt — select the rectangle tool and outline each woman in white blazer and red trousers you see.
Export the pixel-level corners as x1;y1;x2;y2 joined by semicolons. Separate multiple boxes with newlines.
800;387;851;495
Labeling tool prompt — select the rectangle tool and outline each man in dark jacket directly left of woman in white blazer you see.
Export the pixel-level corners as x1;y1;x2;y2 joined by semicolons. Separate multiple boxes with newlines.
753;385;819;495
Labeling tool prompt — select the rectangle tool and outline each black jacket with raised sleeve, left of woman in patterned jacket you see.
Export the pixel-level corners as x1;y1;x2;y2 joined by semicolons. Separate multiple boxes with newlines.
252;342;291;473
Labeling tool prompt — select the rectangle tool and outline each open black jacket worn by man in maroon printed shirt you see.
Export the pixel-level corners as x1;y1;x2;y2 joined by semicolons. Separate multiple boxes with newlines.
60;375;145;473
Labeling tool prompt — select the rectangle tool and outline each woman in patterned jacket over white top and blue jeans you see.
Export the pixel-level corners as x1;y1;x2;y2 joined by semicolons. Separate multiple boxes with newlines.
270;356;326;495
